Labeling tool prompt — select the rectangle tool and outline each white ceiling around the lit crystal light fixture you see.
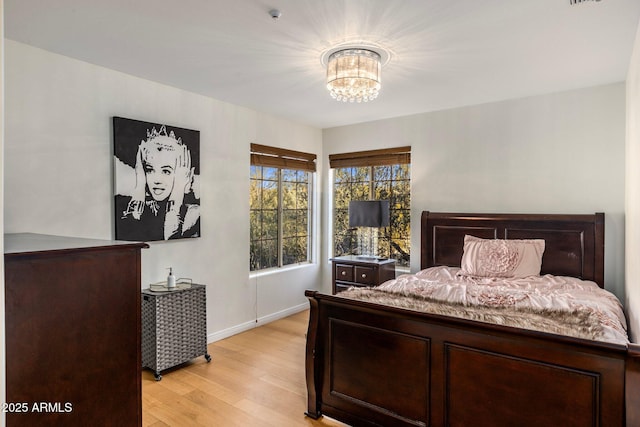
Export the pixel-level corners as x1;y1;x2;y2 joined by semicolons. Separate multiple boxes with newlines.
4;0;640;128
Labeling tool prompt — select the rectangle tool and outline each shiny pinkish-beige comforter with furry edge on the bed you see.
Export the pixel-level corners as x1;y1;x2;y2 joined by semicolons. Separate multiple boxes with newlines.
339;267;629;344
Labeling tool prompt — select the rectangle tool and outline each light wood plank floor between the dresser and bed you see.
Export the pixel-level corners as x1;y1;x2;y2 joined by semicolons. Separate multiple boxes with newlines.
142;311;344;427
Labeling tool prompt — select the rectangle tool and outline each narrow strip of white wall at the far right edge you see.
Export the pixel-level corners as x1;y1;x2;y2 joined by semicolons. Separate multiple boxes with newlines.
625;22;640;342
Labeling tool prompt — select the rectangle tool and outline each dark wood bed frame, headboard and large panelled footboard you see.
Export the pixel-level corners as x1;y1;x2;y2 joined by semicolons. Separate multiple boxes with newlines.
306;212;640;427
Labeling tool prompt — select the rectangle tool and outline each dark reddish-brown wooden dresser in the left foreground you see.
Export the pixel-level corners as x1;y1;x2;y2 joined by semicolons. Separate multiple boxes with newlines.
4;233;147;427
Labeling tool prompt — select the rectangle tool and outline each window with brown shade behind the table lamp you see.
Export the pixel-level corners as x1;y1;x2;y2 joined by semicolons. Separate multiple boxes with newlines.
329;147;411;267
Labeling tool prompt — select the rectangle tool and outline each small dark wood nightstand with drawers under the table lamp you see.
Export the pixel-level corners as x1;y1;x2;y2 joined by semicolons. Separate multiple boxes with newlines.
331;255;396;294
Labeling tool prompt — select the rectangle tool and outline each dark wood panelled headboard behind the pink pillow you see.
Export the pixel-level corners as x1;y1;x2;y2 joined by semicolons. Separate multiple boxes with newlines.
420;211;604;287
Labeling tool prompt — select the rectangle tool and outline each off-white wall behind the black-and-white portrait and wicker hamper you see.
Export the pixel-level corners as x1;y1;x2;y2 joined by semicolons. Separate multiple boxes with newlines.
4;40;322;340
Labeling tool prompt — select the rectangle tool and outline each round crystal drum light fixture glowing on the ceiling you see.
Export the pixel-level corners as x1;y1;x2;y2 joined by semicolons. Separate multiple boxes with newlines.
327;49;381;102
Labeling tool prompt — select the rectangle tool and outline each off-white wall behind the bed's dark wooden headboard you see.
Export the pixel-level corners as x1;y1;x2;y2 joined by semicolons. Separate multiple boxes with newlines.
323;83;625;299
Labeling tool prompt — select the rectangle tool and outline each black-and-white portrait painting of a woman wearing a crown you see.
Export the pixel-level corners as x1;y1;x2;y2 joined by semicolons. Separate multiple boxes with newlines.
113;117;200;241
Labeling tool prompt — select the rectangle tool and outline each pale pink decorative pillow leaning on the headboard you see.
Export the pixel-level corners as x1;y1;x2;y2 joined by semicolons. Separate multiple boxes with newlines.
460;235;544;278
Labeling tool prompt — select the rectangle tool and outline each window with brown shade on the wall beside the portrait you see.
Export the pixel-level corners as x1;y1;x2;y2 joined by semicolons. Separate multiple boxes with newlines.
249;144;316;271
